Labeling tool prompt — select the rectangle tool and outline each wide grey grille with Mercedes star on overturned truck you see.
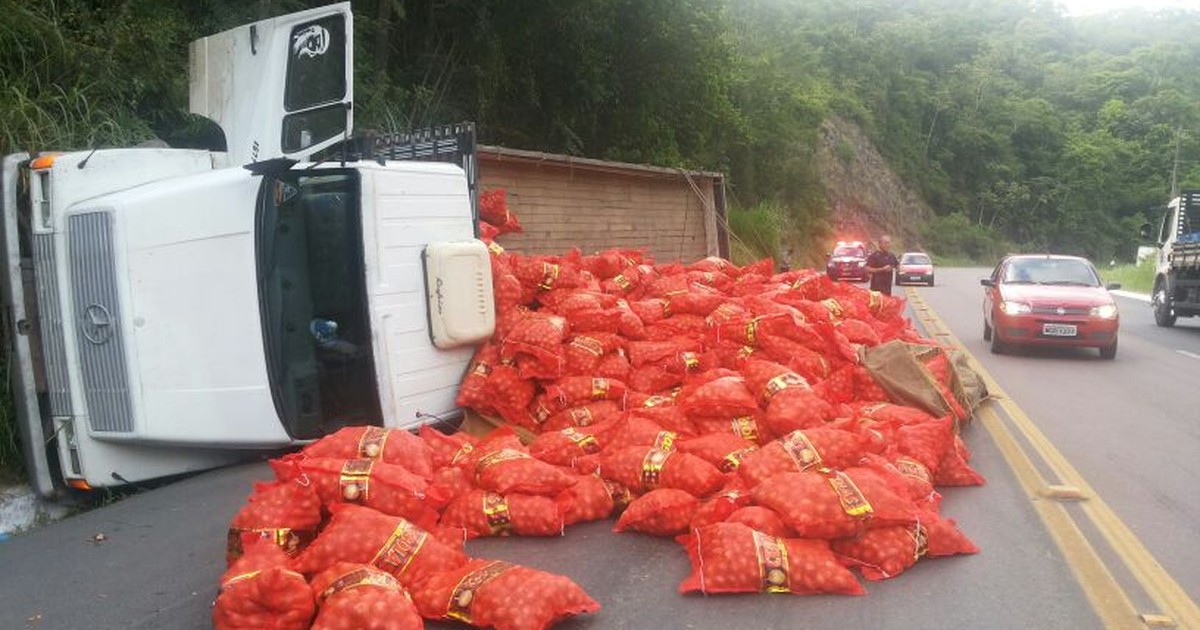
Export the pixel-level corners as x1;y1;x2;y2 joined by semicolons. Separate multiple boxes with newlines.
67;212;133;432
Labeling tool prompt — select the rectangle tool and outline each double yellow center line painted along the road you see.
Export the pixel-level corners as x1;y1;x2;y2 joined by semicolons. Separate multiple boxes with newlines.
908;289;1200;629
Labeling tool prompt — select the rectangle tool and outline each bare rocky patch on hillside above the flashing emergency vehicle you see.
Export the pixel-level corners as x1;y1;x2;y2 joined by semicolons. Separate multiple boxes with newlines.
816;118;934;252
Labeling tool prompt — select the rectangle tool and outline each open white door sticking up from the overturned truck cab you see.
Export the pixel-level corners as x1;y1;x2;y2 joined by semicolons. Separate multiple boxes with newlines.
188;2;354;164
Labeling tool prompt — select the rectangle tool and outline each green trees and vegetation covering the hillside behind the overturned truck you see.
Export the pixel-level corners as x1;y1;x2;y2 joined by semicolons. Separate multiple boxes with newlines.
0;0;1200;482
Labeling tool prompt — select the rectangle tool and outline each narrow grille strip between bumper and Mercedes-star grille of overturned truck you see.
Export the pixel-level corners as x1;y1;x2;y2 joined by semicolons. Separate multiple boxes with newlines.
34;234;71;416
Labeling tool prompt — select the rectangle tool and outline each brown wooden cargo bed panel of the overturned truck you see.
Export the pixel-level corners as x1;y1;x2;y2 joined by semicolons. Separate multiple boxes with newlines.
478;148;724;262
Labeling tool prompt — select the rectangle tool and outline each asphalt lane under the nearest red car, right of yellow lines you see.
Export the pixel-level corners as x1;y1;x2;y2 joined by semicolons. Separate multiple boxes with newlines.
917;269;1200;598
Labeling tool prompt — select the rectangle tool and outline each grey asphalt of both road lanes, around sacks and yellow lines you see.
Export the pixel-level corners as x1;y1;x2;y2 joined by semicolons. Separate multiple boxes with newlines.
9;269;1185;630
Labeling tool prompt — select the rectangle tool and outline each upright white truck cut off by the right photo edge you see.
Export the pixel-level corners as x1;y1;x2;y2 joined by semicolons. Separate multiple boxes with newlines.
1141;190;1200;326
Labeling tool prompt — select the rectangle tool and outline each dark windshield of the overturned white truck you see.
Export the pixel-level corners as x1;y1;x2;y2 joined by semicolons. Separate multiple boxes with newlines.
256;169;380;439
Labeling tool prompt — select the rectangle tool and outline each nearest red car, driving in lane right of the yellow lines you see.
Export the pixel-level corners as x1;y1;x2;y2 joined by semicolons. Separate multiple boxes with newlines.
979;256;1121;359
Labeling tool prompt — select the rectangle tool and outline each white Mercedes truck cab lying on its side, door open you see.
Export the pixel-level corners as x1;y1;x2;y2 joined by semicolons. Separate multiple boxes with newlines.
0;2;494;496
